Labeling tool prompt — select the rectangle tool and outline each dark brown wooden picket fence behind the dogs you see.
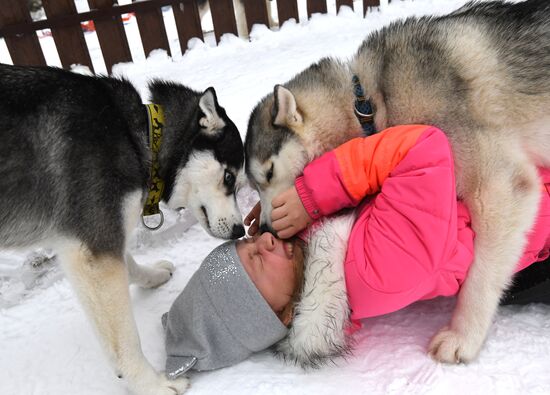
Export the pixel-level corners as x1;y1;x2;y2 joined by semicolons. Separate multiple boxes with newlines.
0;0;380;73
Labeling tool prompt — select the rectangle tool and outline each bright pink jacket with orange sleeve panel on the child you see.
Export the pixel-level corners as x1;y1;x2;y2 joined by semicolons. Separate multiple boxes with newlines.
295;125;550;320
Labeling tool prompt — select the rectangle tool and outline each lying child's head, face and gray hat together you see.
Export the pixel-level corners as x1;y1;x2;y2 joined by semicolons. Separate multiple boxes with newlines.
162;233;303;379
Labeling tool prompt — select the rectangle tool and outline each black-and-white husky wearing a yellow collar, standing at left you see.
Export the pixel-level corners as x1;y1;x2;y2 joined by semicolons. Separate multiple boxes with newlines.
0;65;244;395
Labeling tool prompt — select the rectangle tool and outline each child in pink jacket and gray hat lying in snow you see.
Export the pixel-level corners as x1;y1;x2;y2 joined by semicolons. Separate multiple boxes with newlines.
164;125;550;377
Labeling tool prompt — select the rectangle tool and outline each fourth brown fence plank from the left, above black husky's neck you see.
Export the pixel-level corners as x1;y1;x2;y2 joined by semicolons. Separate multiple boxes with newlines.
136;2;170;57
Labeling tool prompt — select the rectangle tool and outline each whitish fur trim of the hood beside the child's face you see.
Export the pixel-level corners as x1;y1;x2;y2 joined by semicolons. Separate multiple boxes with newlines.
275;211;355;368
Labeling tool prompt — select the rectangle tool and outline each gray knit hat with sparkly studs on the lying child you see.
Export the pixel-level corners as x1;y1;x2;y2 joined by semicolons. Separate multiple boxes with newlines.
162;241;288;379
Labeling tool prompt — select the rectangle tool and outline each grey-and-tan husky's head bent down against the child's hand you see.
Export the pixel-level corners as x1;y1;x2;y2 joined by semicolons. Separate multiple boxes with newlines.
245;58;362;229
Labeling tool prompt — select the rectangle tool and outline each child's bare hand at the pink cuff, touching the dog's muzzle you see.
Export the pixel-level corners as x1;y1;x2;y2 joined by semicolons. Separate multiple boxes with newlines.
271;187;312;239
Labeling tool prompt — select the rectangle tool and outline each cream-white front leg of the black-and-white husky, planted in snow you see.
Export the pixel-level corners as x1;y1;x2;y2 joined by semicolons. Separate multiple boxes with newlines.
60;245;188;395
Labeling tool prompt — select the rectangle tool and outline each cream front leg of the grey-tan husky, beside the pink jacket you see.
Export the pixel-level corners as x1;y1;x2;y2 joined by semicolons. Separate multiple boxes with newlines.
429;142;539;363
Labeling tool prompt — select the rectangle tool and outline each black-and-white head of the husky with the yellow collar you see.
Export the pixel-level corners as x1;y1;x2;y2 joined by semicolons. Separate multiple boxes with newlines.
151;82;245;239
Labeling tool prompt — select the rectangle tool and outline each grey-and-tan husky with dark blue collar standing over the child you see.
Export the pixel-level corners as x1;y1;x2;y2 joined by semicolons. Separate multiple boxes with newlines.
245;0;550;363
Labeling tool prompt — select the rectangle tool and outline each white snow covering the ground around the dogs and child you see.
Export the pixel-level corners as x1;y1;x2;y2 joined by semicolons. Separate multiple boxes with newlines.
0;0;550;395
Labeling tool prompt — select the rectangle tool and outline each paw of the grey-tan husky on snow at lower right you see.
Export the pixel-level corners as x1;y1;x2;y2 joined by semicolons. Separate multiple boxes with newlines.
428;327;481;363
